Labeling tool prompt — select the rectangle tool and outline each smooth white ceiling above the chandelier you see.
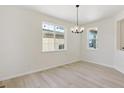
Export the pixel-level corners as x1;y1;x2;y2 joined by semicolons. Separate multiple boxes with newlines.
25;5;124;24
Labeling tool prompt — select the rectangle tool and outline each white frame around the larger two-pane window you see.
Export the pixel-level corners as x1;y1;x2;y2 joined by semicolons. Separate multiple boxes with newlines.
41;21;67;53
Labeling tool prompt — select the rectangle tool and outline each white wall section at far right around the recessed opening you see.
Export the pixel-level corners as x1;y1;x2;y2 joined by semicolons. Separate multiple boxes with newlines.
114;11;124;73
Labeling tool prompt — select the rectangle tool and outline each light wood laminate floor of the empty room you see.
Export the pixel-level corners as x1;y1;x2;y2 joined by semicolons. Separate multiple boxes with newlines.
4;62;124;88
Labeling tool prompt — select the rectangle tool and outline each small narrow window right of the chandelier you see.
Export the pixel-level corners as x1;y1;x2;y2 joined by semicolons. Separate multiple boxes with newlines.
88;29;97;49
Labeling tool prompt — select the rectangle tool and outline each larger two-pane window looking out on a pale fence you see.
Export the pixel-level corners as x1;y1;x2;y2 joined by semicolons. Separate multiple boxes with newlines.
42;22;65;51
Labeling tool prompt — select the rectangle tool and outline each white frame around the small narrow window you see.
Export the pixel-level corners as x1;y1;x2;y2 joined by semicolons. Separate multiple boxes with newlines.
87;27;98;50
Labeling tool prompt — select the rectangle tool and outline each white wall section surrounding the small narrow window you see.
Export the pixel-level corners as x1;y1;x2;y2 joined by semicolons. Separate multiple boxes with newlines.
82;18;114;67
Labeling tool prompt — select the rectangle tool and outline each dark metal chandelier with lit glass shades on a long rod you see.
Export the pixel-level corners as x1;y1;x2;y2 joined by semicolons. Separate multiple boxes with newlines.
71;5;84;33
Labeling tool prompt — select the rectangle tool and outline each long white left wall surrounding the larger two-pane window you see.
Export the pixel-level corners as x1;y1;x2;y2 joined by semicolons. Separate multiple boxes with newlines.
0;6;80;80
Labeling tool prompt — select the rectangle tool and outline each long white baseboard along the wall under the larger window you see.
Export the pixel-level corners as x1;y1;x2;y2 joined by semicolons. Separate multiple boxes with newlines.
0;60;80;81
